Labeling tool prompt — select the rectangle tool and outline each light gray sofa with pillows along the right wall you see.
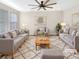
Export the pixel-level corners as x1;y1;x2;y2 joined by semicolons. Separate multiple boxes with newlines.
59;28;79;50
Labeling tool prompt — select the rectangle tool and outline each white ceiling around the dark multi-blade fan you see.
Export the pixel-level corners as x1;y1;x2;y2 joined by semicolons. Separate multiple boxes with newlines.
0;0;79;11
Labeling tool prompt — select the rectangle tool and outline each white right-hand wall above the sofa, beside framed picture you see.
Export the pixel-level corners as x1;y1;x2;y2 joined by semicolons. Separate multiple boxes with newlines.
64;5;79;25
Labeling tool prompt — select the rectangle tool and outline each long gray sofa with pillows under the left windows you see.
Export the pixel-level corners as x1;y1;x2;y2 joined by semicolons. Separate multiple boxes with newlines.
0;30;29;55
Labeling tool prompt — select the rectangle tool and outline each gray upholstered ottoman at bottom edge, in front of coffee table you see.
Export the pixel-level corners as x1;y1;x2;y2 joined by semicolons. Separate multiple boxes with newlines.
42;49;64;59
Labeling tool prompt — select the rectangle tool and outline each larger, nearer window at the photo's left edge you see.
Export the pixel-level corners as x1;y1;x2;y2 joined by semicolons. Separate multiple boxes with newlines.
0;9;8;33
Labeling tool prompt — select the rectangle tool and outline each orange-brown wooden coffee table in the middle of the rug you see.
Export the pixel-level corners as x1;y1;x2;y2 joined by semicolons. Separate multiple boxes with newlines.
35;37;50;50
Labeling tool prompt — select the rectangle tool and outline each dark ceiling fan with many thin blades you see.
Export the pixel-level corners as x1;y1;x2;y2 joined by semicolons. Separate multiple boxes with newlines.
29;0;57;10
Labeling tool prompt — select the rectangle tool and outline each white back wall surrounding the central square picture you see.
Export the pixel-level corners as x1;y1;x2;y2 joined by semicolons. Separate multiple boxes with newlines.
20;11;63;34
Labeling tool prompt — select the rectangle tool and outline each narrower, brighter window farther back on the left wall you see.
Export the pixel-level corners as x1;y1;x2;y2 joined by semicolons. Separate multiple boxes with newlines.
10;13;17;30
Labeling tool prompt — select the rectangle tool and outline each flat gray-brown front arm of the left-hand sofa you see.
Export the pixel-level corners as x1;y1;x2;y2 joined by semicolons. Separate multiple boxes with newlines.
0;38;14;54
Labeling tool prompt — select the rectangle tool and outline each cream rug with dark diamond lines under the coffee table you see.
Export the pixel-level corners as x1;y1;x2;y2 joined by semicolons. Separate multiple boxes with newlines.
1;36;79;59
